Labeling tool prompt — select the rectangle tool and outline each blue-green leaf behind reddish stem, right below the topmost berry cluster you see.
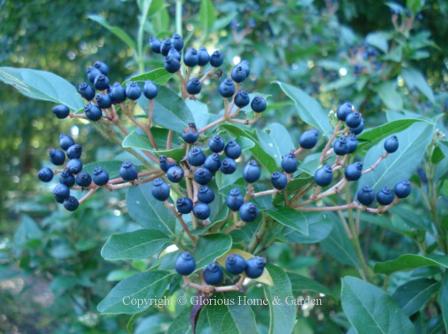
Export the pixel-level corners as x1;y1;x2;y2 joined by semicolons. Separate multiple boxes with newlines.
138;86;194;133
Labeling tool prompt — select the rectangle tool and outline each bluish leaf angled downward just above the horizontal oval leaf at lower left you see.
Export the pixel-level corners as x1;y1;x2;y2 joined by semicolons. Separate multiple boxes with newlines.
126;183;176;236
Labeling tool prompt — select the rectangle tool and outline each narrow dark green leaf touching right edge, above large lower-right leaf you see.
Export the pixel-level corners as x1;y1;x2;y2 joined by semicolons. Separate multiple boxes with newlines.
375;254;448;274
